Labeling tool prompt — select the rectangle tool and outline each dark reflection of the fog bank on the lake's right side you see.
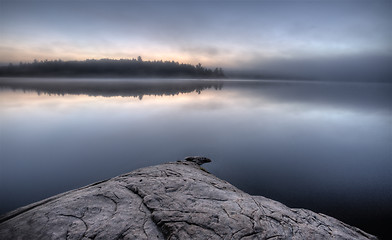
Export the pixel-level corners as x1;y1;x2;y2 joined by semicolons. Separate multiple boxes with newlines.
224;80;392;113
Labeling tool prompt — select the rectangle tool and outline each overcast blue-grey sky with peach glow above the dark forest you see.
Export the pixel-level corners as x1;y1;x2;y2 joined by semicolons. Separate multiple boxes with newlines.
0;0;392;79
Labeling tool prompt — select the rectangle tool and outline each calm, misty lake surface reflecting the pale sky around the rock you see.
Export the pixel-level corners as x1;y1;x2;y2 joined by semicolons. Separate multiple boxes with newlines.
0;79;392;236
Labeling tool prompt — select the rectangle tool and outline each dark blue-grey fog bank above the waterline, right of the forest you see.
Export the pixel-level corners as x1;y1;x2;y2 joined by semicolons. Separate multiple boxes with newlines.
233;54;392;81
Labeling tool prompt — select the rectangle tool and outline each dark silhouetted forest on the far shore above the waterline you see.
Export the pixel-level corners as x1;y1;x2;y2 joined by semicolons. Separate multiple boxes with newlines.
0;56;225;78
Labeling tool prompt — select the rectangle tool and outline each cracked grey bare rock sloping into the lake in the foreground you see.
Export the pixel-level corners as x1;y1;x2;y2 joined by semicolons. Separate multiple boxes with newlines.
0;161;376;240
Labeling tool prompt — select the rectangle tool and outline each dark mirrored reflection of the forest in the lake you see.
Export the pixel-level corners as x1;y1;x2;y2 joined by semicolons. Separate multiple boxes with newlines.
0;79;223;99
